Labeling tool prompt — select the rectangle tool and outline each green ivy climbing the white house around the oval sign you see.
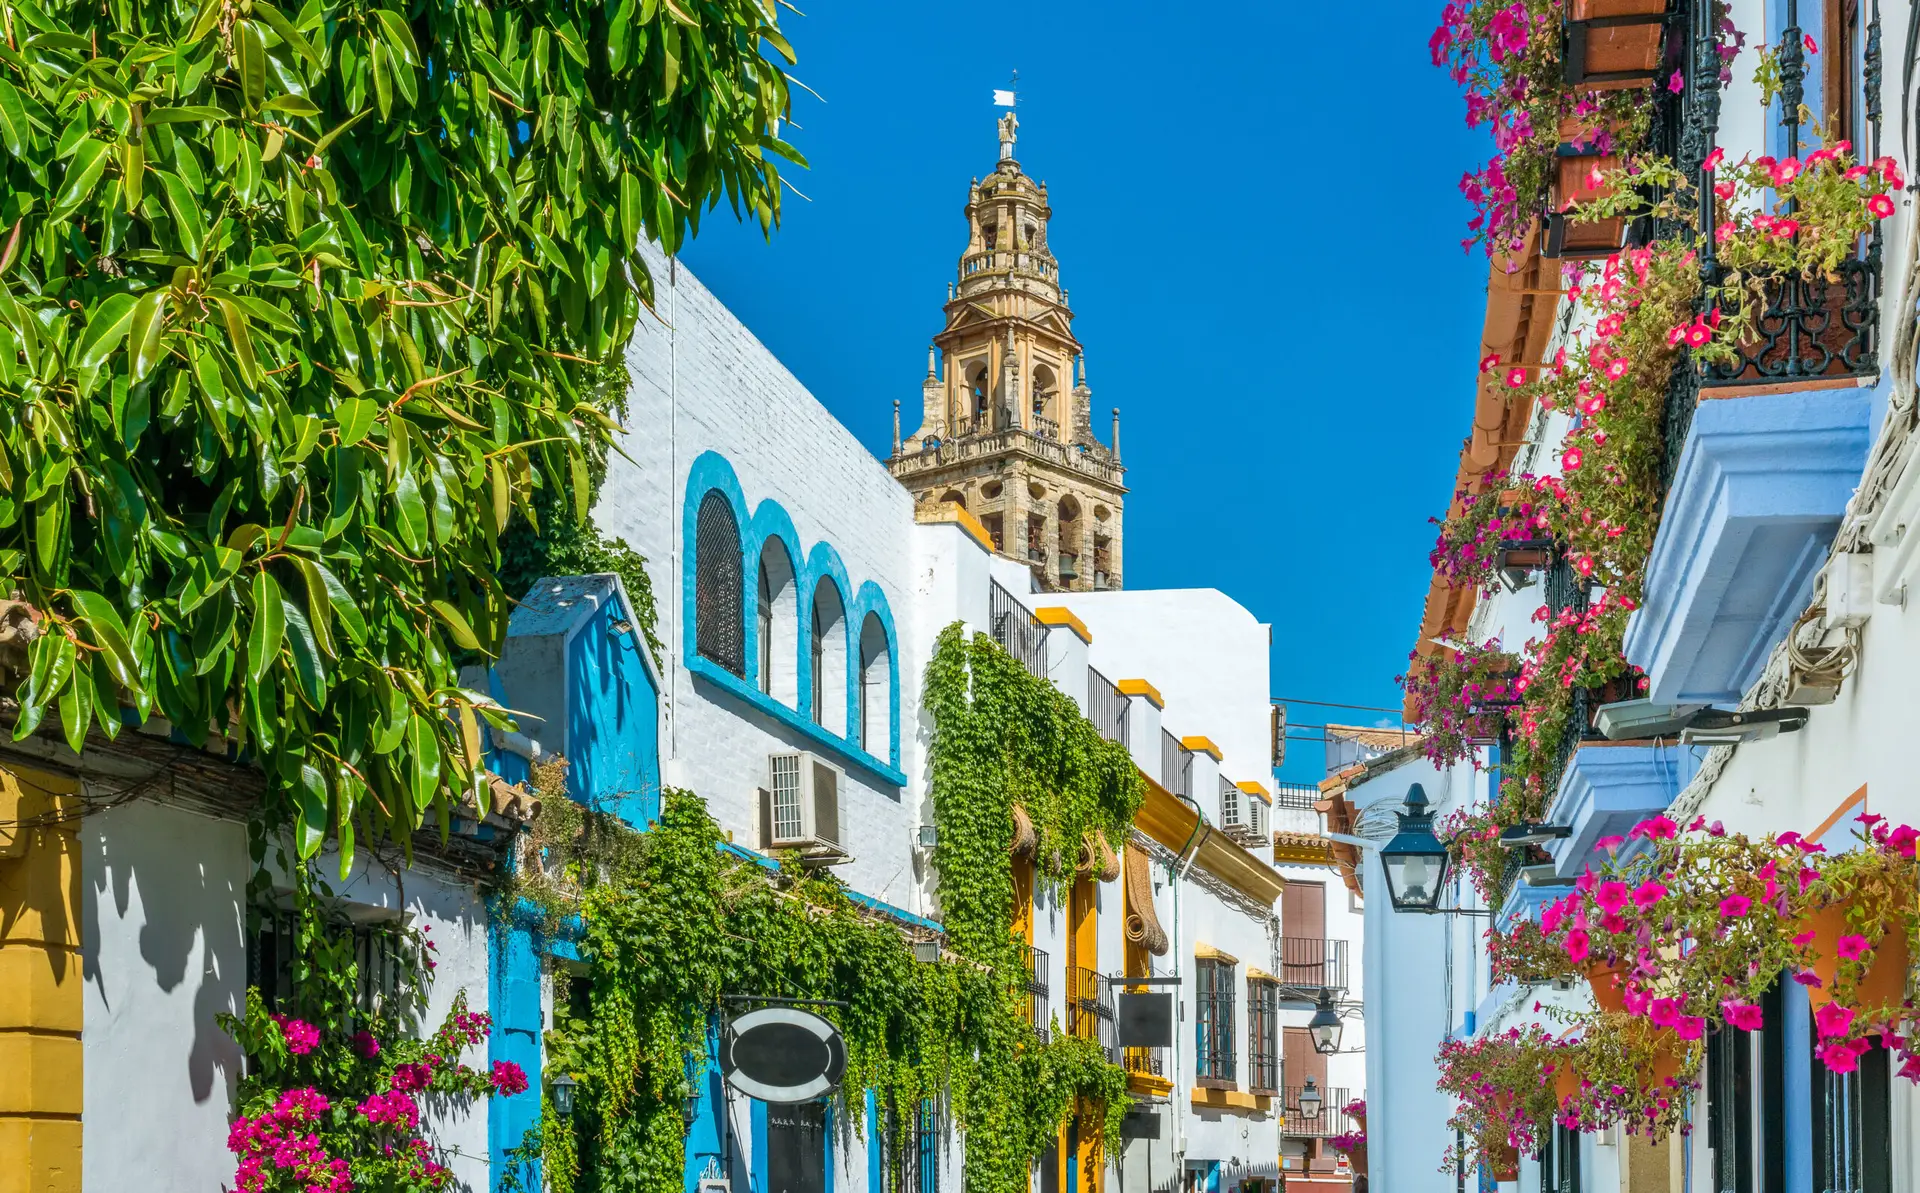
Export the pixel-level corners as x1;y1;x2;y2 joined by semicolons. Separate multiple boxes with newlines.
501;626;1142;1193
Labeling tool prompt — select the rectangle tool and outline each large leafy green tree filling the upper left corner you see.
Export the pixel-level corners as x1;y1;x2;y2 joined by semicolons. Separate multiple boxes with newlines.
0;0;799;855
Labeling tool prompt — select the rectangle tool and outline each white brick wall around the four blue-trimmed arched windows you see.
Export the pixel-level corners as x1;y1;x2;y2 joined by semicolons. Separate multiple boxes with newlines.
595;250;929;913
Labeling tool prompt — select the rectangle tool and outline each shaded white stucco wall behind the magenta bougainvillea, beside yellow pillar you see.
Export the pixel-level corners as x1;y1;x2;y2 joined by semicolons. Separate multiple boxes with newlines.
81;801;503;1193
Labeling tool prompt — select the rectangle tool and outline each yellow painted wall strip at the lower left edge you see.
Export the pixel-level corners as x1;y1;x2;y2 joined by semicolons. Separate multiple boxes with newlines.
0;770;83;1193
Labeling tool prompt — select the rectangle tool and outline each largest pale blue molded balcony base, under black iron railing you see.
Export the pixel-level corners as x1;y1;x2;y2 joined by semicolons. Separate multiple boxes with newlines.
1626;388;1872;703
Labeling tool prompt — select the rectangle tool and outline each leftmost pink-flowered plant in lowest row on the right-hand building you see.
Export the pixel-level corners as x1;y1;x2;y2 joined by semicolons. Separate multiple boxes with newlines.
1434;1024;1565;1170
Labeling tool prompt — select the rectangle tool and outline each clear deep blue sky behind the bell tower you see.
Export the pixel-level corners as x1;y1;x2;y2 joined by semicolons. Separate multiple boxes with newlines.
684;0;1490;780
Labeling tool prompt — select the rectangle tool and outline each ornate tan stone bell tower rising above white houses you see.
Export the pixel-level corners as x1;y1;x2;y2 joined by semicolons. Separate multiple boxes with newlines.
887;111;1127;592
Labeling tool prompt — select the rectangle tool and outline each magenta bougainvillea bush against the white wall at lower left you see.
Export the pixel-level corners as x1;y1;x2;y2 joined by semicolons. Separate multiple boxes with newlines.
219;910;528;1193
